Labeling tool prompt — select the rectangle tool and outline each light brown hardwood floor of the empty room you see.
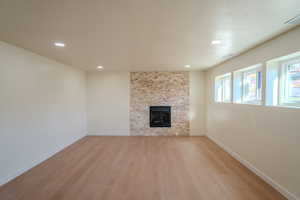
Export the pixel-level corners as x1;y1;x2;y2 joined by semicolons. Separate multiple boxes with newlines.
0;137;285;200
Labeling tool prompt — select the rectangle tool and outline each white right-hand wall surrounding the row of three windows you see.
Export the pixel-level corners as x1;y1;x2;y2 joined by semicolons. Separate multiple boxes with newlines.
206;27;300;199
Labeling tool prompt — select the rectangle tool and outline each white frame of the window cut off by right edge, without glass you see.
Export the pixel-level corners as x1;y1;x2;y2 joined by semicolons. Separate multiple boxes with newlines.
277;56;300;108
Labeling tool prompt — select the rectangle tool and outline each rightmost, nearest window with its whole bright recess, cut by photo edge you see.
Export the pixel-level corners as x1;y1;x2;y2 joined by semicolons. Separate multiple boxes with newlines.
266;52;300;107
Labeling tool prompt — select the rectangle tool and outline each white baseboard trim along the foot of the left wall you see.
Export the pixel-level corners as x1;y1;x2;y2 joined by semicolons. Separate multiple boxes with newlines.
0;135;86;186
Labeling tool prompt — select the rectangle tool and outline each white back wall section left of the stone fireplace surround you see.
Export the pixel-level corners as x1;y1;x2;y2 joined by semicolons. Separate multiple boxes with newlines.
87;71;129;135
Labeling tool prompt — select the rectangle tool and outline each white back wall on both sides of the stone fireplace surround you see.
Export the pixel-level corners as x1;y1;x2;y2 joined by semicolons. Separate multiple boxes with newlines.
87;71;205;135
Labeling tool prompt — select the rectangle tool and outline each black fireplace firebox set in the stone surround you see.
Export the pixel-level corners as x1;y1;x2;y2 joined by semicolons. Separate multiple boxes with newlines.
150;106;171;127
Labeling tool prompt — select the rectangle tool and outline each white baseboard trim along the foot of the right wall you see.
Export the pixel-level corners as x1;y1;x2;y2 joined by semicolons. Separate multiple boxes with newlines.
206;134;300;200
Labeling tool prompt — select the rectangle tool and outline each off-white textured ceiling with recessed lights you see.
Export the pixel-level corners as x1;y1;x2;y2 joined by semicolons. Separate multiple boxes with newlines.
0;0;300;71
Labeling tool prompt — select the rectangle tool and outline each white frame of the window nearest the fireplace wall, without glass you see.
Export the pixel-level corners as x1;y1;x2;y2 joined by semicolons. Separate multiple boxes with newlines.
214;72;232;103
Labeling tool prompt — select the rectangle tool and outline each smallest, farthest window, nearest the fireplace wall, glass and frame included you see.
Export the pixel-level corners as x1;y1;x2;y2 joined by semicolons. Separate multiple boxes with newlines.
215;73;231;102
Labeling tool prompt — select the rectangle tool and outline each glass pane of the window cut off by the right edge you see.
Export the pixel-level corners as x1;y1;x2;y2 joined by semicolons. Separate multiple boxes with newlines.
286;63;300;102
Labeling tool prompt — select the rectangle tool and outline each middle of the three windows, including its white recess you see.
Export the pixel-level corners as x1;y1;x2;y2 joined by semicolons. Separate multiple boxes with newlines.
233;64;262;104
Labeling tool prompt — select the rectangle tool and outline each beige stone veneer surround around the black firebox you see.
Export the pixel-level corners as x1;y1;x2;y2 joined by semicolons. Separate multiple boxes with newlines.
130;72;189;136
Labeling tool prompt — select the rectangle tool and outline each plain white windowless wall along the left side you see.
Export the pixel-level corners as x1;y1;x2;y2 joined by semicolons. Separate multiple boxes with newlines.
0;41;86;185
